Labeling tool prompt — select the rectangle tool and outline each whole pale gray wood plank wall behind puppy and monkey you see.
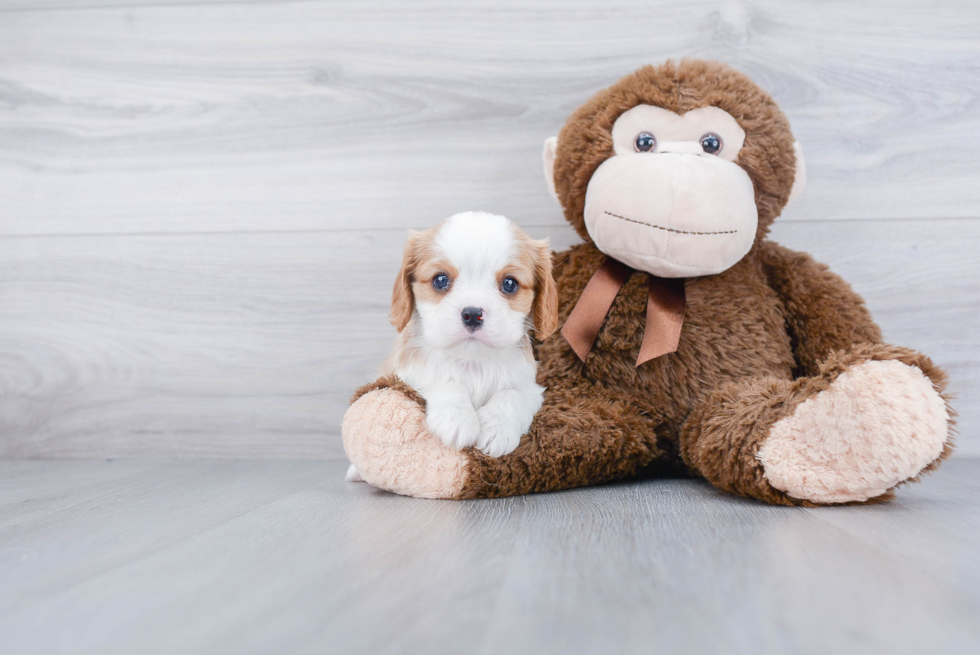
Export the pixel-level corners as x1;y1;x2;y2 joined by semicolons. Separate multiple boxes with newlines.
0;0;980;458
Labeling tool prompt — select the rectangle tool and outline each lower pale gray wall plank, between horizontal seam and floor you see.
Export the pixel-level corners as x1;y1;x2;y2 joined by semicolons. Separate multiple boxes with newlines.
0;219;980;458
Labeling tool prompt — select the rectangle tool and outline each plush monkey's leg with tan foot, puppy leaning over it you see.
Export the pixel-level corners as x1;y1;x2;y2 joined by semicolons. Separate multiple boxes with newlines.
342;378;658;499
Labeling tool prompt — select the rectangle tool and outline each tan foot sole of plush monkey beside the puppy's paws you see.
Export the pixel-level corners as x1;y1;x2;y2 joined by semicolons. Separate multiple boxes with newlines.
341;389;467;498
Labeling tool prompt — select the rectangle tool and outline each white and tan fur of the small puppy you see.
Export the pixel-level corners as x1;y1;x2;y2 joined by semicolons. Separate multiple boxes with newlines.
382;212;558;457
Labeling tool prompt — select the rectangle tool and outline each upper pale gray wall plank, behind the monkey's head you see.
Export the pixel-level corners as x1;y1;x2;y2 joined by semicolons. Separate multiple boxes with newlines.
0;0;980;234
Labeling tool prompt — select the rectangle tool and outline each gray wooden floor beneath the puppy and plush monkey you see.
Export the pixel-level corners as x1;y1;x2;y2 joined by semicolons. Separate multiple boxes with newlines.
0;458;980;655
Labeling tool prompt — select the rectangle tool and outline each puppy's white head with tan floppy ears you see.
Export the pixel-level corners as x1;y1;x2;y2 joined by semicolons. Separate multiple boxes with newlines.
391;212;558;348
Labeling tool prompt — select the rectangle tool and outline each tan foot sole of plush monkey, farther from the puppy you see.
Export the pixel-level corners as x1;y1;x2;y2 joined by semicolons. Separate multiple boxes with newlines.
757;360;949;503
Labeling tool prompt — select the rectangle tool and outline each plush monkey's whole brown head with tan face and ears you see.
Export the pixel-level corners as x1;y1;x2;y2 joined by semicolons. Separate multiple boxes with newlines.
544;60;806;277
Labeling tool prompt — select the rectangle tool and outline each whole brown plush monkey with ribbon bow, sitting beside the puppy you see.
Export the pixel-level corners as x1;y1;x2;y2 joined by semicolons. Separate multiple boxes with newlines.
343;61;952;505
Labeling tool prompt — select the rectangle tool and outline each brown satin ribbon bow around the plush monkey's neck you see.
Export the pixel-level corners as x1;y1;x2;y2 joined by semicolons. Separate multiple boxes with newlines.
561;257;685;366
